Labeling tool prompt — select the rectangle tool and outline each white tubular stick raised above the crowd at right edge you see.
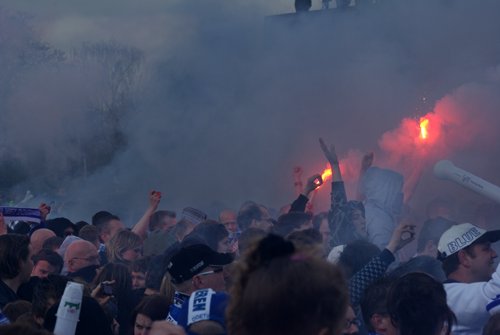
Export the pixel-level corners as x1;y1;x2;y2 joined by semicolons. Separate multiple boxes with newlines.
434;160;500;203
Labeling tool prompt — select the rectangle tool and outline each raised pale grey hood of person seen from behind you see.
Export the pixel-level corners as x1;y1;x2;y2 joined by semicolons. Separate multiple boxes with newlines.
361;167;404;214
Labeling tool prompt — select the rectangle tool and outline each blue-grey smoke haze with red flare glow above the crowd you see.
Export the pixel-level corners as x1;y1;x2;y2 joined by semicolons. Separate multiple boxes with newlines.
0;0;500;224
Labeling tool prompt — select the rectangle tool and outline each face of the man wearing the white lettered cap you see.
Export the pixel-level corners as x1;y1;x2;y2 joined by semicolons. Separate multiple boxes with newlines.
468;242;498;282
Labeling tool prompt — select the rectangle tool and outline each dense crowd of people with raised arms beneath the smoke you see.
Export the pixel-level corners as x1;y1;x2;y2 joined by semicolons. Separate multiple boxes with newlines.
0;141;500;335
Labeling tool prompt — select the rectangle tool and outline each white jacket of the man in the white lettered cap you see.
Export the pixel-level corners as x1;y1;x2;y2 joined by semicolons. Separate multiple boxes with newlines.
444;265;500;335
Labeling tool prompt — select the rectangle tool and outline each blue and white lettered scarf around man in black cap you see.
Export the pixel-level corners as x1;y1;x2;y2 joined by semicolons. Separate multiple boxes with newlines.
178;288;229;333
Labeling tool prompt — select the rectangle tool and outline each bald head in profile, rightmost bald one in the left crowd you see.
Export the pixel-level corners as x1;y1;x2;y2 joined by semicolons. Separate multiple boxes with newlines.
64;240;99;273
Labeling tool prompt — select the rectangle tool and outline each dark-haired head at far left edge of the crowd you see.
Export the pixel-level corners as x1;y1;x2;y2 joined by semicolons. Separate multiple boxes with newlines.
0;234;30;279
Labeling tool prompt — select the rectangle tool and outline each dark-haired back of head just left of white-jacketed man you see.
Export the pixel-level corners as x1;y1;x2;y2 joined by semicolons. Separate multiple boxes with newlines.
387;273;455;335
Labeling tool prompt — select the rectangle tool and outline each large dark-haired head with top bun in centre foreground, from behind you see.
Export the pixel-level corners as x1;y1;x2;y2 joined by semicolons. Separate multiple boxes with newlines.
227;235;348;335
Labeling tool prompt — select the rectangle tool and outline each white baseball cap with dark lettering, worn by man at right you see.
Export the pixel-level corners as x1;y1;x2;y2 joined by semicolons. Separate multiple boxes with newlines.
438;223;500;259
